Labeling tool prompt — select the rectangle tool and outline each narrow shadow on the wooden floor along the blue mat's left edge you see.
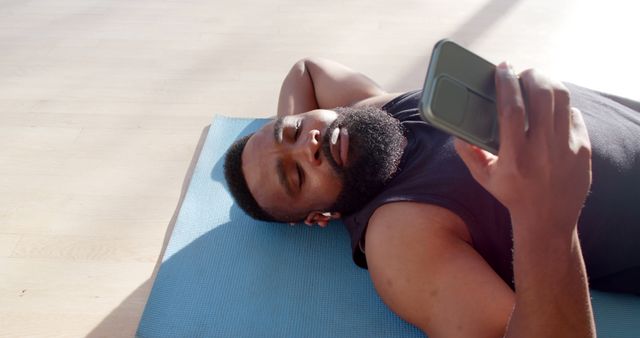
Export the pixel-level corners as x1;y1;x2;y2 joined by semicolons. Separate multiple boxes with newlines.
87;125;211;337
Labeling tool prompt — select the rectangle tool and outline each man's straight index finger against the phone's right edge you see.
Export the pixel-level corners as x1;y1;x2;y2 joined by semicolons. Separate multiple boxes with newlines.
495;62;525;156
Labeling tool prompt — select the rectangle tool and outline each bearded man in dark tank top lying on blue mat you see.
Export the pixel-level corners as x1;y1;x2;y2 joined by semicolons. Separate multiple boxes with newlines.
225;58;640;337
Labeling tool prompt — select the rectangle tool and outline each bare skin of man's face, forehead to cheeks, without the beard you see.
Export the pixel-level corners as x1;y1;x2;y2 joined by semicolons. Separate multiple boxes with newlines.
242;110;342;225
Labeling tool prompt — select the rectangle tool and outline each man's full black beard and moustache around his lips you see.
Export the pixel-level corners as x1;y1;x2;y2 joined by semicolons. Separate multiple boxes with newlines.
322;107;404;216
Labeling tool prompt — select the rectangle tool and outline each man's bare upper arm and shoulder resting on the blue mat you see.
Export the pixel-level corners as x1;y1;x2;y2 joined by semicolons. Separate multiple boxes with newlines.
365;202;515;338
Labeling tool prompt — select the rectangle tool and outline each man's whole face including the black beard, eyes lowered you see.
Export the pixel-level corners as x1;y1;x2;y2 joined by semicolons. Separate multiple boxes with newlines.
242;110;404;221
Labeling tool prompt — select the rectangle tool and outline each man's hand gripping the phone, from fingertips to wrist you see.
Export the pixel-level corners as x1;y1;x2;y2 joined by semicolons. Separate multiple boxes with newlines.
456;63;591;233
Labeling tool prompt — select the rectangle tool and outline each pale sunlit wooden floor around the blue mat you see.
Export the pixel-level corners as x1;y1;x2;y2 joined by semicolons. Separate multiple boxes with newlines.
0;0;640;337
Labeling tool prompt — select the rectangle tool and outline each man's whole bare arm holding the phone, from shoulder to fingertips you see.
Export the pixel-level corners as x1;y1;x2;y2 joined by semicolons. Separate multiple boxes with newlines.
365;66;595;337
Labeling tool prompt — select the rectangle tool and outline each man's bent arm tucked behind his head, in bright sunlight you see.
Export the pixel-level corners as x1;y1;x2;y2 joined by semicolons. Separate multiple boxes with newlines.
278;58;391;116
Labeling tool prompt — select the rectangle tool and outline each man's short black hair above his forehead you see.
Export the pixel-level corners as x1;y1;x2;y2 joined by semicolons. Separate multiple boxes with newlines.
224;134;275;222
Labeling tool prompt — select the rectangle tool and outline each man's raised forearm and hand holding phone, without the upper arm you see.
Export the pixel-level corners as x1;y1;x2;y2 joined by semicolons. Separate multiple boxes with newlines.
456;63;595;337
